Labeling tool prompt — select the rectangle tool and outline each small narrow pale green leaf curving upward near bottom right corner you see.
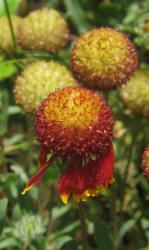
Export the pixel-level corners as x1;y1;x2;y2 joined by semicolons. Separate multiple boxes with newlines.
117;219;136;245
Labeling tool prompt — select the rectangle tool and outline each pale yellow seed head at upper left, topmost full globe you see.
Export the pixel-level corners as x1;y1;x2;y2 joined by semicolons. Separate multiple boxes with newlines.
17;8;69;53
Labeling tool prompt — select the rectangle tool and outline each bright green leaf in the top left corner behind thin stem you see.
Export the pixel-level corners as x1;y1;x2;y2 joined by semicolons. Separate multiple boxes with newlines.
0;0;21;16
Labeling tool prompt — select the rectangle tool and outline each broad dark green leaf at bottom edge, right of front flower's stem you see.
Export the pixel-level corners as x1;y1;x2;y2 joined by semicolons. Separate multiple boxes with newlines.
94;220;112;250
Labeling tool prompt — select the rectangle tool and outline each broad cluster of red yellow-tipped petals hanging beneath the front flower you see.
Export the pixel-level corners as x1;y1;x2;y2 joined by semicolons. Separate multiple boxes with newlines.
58;143;114;204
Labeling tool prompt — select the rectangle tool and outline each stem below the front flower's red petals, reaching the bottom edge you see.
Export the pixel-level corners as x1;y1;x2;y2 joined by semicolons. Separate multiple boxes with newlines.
78;202;88;250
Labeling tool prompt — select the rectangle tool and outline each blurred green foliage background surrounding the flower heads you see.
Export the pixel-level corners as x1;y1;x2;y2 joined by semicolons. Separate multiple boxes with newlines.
0;0;149;250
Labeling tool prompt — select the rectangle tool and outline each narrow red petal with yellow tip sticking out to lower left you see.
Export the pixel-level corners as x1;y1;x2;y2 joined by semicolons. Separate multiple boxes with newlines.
21;155;55;195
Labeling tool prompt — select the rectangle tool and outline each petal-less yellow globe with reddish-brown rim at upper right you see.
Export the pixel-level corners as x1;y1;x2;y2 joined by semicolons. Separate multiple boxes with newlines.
71;28;138;90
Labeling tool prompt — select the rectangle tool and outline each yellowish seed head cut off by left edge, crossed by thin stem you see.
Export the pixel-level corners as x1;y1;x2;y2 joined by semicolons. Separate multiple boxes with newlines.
0;16;22;54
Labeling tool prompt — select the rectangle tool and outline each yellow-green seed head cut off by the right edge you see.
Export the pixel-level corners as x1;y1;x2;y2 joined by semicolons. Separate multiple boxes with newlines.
120;68;149;116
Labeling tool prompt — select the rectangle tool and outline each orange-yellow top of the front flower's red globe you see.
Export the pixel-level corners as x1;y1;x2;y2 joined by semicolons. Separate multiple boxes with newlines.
44;88;102;129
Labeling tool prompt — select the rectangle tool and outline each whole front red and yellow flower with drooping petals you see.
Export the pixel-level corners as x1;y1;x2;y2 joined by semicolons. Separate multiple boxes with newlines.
22;87;114;203
